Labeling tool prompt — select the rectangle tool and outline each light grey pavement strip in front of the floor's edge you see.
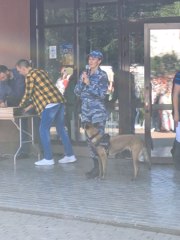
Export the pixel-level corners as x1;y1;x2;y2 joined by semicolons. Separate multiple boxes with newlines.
0;210;179;240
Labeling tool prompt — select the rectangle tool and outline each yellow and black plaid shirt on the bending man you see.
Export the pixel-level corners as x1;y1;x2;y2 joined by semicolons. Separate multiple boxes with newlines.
19;69;65;114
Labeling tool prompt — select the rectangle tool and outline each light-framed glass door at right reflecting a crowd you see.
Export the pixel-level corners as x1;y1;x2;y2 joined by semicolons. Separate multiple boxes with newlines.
144;23;180;163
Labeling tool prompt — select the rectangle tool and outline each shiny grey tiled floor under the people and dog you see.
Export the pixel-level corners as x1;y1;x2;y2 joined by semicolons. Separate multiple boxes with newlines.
0;153;180;234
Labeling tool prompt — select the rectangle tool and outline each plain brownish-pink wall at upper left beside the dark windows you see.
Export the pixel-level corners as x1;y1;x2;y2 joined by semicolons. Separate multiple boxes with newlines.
0;0;30;68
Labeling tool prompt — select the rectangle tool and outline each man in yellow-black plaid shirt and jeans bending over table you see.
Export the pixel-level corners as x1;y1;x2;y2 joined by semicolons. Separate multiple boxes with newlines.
16;59;76;166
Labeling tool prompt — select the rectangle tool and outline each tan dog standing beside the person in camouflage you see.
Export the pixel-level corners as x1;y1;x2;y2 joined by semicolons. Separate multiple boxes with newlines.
85;124;151;179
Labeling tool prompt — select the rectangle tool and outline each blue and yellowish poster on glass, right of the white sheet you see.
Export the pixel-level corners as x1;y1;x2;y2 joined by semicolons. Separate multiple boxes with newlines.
60;43;74;65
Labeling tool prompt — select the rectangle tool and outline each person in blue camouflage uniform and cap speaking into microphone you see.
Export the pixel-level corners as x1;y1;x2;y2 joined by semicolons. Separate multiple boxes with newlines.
74;51;108;178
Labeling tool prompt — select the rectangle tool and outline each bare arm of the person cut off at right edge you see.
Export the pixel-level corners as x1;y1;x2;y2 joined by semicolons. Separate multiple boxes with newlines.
172;84;180;127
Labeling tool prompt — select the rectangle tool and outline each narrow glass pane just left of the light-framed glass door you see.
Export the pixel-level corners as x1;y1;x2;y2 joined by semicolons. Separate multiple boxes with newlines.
126;23;144;135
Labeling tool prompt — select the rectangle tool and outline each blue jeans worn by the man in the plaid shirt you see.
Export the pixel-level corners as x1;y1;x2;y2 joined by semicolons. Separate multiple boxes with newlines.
39;103;74;160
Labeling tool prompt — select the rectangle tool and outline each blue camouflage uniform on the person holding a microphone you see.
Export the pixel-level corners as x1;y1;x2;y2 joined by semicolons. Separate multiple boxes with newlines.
74;68;108;158
